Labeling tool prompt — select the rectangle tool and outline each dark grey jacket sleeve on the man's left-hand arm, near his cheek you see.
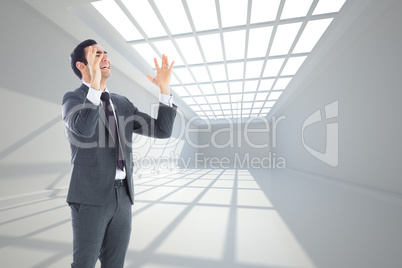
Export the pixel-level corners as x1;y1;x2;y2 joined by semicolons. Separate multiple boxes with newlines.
62;92;99;138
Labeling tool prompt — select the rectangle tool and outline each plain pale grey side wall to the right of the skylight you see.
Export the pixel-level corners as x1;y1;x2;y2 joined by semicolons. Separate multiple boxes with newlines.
273;0;402;194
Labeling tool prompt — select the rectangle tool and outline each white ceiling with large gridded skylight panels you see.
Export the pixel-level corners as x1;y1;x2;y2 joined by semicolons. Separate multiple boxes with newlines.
26;0;351;123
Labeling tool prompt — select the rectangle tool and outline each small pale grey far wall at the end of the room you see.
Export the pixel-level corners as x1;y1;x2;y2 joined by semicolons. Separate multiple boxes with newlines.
195;118;272;169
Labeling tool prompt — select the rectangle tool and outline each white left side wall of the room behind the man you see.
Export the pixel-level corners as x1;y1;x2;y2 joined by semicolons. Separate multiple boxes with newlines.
0;0;196;202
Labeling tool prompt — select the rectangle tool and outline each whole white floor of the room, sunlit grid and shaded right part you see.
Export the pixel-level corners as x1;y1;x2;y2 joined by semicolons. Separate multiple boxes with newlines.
0;169;402;268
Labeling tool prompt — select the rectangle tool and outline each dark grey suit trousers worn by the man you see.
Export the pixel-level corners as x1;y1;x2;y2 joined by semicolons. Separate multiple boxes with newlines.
69;180;132;268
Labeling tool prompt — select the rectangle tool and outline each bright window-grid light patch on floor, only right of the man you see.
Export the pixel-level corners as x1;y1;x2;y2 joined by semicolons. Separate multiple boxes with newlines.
128;169;314;267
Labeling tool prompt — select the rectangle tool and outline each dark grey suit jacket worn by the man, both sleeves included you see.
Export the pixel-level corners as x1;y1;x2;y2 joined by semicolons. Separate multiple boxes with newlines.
62;84;177;206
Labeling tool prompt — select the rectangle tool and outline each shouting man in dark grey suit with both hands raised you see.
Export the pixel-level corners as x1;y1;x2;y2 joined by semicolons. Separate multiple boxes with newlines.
62;40;177;268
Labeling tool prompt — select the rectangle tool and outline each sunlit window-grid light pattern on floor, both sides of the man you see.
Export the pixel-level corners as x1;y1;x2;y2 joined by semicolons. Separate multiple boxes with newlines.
0;169;314;268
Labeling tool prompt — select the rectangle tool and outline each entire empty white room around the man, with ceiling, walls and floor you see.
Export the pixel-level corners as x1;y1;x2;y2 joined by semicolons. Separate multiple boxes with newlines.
0;0;402;268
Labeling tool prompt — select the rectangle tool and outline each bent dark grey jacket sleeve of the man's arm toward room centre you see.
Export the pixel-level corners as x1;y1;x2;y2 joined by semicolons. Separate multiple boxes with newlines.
133;100;177;139
